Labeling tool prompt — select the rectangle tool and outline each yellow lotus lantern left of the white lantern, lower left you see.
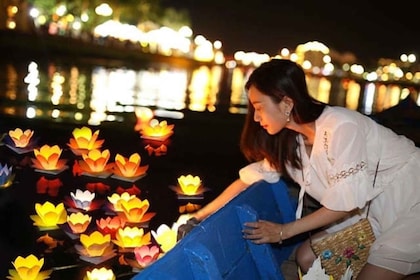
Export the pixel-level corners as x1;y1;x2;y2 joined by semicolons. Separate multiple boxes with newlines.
30;201;67;229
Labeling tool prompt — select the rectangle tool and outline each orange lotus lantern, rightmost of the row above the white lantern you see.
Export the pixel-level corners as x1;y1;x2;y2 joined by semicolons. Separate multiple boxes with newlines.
114;153;149;178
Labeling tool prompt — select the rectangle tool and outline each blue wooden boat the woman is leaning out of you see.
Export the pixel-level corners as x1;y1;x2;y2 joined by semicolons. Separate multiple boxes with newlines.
133;180;297;280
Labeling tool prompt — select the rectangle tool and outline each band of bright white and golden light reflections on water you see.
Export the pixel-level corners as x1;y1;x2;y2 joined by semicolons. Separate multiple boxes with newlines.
0;58;419;125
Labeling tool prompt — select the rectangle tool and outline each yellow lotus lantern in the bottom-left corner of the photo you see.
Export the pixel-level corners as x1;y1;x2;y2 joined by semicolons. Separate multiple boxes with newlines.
7;254;52;280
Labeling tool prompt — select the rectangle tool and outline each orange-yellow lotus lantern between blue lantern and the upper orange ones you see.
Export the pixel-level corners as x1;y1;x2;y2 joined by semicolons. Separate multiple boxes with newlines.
32;145;66;170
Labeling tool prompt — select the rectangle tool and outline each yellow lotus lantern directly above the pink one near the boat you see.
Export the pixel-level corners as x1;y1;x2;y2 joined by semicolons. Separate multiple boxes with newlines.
112;226;152;248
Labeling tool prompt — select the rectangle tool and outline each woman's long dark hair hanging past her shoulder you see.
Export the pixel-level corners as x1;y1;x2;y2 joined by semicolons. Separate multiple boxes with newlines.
240;59;325;177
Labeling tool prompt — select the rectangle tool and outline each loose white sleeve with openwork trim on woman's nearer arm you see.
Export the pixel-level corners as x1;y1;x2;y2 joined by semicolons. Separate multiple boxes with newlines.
320;122;376;211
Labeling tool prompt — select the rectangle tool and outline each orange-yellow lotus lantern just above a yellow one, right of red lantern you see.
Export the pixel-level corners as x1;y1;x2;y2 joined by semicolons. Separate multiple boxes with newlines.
118;197;156;224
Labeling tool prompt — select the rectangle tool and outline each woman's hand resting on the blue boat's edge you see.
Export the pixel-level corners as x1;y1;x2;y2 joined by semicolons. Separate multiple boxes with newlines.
242;220;283;244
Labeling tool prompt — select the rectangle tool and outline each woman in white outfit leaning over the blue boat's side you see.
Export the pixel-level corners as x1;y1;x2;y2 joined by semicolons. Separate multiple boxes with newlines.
238;59;420;279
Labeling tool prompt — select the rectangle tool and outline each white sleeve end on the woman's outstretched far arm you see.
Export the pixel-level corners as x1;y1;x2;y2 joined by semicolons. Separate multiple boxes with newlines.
239;159;280;185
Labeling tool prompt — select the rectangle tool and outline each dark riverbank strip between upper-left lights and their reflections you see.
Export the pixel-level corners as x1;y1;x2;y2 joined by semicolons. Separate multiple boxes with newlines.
0;30;212;67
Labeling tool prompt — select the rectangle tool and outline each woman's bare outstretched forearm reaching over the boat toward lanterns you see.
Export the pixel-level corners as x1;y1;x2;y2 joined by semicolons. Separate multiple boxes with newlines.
191;179;250;221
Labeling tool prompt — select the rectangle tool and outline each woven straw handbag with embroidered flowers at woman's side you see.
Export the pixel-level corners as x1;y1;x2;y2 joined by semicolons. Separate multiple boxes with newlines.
310;162;379;279
